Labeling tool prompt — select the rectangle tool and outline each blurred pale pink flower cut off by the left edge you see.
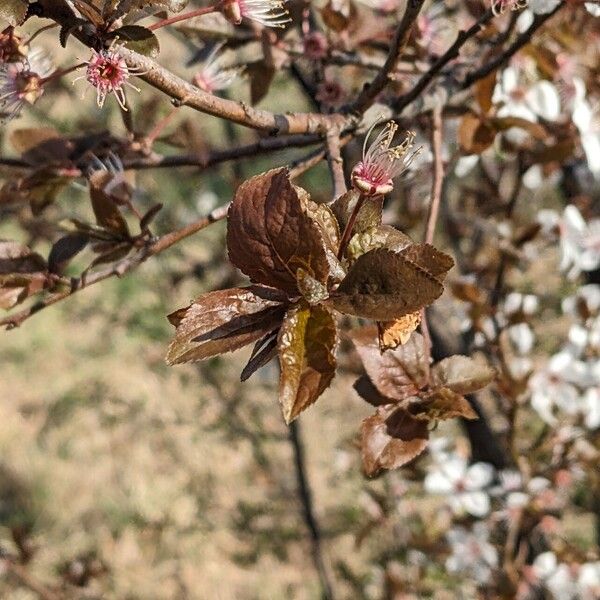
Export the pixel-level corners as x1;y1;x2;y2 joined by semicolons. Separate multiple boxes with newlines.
0;48;54;120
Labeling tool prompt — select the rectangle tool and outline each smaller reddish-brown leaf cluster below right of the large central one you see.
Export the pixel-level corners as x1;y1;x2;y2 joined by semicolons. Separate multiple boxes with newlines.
351;327;495;475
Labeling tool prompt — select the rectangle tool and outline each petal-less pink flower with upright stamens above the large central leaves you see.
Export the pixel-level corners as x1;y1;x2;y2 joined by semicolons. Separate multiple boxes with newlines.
352;121;419;196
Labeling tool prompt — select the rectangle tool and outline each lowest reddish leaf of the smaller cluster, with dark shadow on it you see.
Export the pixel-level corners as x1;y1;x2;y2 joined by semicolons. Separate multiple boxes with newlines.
361;406;429;477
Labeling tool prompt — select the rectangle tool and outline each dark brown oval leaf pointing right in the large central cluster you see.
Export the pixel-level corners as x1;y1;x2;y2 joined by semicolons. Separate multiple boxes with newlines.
330;248;444;321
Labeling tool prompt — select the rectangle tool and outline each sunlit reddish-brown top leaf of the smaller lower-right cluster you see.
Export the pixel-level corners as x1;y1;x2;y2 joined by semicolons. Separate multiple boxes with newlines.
350;326;429;402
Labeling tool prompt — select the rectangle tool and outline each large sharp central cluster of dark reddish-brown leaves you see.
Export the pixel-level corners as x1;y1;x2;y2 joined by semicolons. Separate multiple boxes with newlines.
167;169;453;423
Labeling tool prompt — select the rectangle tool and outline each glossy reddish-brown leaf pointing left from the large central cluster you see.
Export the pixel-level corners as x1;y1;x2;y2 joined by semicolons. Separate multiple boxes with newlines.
167;286;285;365
